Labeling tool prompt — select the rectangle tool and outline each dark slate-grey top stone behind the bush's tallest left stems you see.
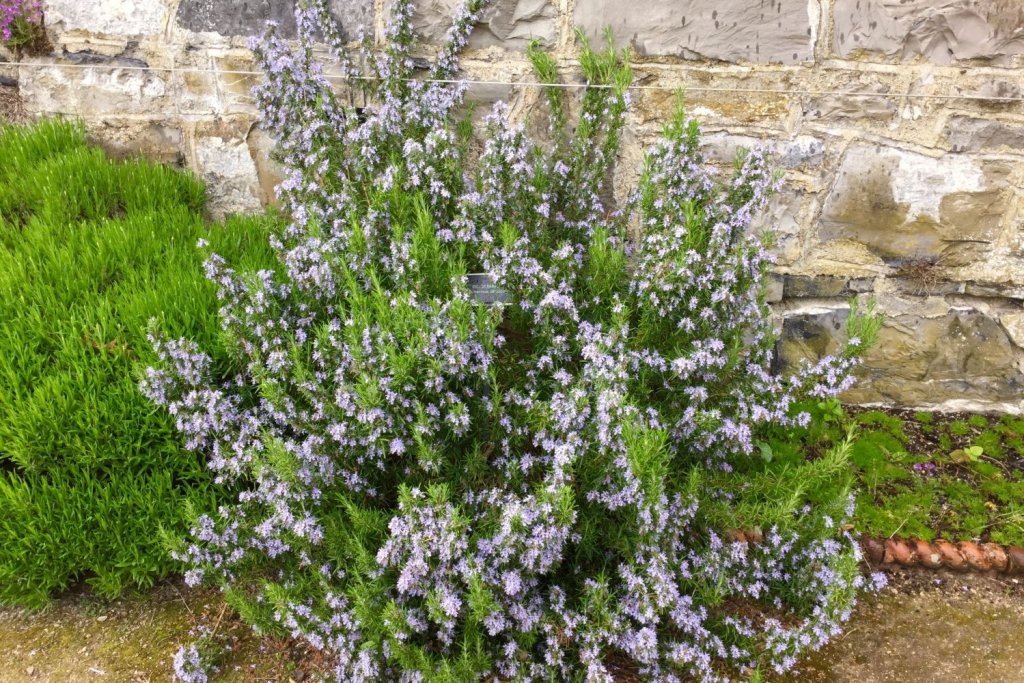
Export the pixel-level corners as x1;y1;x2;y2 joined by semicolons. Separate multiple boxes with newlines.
175;0;374;38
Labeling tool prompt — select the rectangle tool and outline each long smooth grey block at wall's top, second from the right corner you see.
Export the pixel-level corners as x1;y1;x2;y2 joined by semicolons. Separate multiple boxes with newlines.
573;0;818;63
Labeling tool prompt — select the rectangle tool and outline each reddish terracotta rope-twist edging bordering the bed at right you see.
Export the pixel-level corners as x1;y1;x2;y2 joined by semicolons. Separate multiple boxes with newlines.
727;529;1024;577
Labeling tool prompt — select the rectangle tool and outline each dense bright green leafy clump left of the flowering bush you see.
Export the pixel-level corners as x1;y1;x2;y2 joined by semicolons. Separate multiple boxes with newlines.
0;121;268;605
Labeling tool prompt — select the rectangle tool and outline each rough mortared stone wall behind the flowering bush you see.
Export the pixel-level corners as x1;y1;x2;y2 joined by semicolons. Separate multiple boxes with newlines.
0;0;1024;412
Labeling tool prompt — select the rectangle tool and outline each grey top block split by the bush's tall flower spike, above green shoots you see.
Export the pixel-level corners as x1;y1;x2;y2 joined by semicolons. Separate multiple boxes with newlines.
388;0;558;50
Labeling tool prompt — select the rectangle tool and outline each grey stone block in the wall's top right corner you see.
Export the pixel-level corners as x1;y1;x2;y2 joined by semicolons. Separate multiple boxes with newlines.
834;0;1024;65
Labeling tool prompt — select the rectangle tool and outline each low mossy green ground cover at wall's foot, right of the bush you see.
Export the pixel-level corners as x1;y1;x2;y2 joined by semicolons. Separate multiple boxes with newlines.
772;405;1024;546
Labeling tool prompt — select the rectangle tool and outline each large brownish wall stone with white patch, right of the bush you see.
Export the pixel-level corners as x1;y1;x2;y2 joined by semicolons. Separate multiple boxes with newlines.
819;144;1009;260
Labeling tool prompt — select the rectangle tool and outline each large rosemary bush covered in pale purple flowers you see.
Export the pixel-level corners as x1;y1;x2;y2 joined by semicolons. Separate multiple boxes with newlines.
149;0;877;682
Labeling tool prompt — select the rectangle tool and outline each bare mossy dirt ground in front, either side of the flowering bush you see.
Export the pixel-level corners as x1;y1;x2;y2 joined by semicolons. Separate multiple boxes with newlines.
0;570;1024;683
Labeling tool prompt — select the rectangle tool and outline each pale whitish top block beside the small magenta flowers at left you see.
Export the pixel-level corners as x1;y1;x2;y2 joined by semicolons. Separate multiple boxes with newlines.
46;0;169;36
